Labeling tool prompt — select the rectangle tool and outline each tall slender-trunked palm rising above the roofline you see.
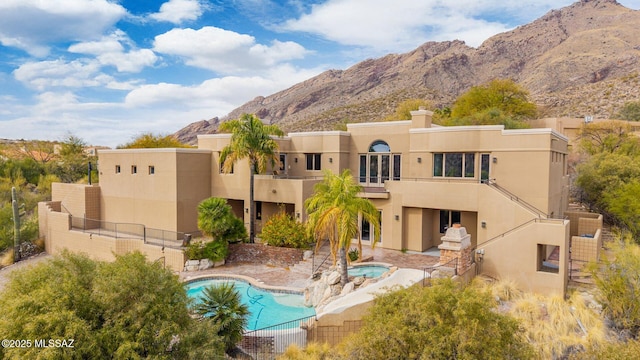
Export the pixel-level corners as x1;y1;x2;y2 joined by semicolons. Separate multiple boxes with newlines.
219;114;284;243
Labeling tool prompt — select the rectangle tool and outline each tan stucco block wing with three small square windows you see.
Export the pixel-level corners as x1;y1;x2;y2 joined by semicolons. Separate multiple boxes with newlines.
100;149;211;232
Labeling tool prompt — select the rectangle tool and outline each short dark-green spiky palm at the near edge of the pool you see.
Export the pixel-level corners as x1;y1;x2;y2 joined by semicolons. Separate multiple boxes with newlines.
194;282;249;351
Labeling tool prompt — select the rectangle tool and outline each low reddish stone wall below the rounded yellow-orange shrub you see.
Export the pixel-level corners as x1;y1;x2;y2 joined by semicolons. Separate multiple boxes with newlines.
226;244;303;267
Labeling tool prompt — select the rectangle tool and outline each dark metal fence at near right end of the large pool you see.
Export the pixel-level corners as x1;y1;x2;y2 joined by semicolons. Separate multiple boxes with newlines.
239;315;316;360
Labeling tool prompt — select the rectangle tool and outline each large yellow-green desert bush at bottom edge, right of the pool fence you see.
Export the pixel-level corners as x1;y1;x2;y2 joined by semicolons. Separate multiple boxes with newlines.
341;279;532;359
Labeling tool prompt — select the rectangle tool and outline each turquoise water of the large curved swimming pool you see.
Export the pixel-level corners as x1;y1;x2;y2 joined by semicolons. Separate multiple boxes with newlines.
186;279;316;330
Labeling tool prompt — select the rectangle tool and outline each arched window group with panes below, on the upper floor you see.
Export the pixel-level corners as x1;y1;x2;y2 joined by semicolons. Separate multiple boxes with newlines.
358;140;400;186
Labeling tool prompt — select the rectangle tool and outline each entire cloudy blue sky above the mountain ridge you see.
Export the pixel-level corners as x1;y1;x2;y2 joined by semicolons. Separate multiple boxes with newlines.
0;0;640;147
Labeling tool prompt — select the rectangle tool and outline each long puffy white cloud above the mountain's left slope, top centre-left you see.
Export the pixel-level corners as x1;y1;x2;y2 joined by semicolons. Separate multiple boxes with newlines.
154;26;307;74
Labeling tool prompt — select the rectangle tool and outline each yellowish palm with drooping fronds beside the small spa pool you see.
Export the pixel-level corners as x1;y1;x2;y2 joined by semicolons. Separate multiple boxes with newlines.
305;169;380;286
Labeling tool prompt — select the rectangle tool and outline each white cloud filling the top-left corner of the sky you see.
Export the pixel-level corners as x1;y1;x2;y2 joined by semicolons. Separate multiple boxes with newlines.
0;0;127;57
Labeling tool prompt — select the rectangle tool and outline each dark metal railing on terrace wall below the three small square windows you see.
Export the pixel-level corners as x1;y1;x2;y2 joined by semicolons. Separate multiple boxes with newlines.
70;216;186;247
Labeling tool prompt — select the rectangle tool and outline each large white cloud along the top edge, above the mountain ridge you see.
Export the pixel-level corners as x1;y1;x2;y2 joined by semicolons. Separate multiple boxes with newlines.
279;0;600;54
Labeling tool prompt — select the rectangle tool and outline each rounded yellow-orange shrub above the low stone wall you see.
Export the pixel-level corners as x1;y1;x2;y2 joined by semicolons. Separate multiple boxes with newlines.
260;212;311;249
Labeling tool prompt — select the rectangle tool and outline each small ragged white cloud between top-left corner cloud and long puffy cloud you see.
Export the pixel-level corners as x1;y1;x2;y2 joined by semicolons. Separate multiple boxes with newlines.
68;30;158;72
